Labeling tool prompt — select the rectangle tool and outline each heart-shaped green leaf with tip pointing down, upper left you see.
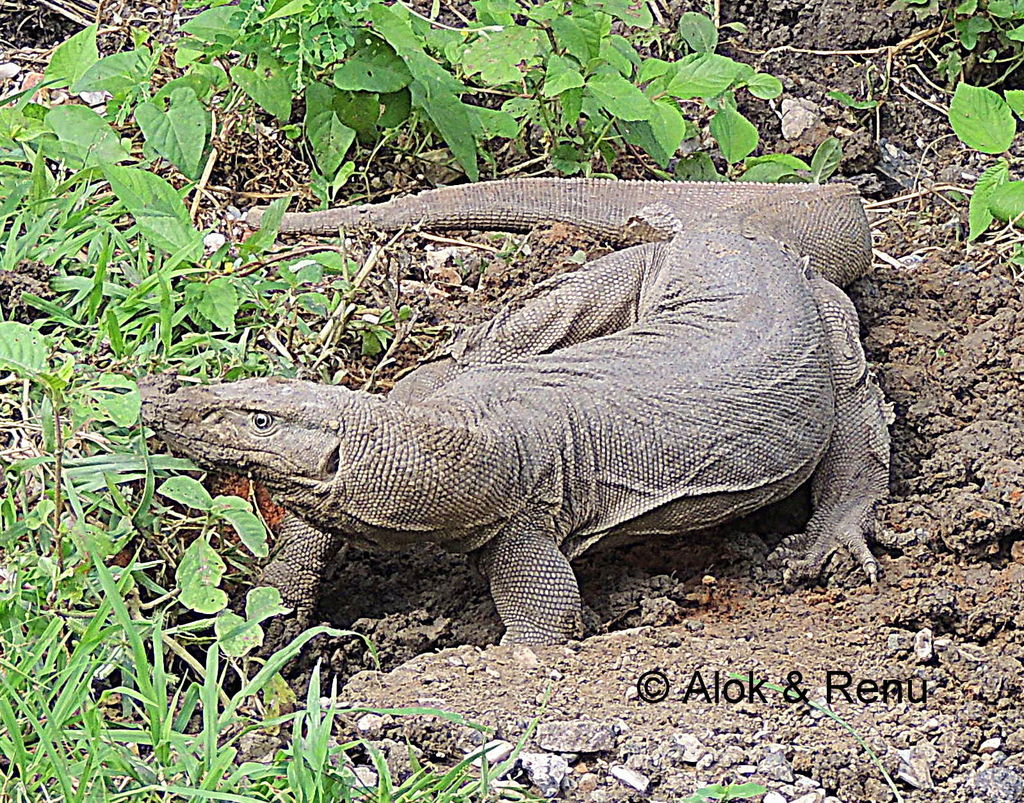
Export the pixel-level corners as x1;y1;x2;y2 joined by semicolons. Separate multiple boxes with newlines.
135;87;210;180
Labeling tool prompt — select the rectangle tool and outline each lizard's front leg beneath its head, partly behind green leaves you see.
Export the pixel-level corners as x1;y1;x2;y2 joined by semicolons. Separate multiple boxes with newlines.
259;513;340;654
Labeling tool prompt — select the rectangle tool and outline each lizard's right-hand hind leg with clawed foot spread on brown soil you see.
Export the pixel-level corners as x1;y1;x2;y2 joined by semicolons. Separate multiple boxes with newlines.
769;276;891;585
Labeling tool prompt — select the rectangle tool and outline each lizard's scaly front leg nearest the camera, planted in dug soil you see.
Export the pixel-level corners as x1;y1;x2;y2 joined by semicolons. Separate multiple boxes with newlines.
479;511;583;644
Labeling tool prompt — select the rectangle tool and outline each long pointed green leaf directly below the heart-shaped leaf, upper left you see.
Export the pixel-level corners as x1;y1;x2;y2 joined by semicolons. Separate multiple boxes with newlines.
102;165;203;258
